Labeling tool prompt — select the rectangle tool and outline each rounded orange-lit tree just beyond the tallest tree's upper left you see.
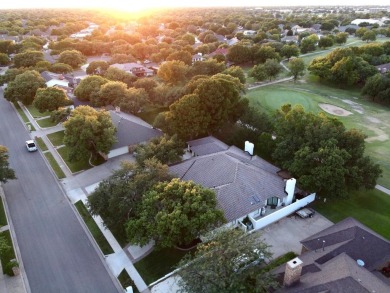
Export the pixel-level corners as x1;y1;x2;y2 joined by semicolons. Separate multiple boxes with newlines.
157;61;189;84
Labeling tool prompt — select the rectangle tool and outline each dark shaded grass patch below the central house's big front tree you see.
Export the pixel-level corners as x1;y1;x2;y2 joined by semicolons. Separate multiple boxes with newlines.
134;248;194;284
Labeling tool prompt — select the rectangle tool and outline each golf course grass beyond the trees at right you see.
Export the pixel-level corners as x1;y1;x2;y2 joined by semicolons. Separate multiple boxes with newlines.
246;81;390;188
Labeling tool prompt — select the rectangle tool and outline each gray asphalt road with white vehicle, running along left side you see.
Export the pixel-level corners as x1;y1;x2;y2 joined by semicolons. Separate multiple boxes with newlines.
0;90;118;293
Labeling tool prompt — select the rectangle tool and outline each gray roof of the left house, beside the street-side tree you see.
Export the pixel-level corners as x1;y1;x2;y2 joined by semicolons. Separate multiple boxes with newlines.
110;111;162;149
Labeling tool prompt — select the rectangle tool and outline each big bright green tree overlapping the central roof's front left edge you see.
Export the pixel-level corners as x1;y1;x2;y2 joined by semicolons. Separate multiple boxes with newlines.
126;178;225;248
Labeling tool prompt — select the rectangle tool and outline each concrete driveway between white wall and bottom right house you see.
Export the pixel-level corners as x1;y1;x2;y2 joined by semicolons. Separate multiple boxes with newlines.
255;212;333;258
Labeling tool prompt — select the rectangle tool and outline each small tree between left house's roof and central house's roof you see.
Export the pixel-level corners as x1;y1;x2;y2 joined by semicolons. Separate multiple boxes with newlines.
135;135;184;166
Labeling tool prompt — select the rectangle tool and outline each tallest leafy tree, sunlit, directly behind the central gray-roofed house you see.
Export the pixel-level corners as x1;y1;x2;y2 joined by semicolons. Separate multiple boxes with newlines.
166;74;247;139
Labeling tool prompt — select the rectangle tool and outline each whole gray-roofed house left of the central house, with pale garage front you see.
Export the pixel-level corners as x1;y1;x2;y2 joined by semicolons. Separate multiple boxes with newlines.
107;111;162;159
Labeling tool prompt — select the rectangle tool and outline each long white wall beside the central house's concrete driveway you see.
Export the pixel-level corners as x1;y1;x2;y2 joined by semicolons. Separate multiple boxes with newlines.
249;193;316;231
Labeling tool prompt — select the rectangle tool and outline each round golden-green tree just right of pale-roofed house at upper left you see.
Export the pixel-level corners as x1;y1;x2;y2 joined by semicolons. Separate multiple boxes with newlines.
74;75;108;103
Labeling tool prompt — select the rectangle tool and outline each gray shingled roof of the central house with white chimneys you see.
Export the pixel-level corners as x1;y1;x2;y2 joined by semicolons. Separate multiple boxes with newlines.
170;137;286;222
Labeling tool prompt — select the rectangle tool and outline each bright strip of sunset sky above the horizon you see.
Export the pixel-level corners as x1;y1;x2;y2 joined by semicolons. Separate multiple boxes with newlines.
0;0;389;11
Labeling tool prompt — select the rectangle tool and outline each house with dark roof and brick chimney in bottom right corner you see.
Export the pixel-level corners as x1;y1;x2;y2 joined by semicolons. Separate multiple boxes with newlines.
275;218;390;293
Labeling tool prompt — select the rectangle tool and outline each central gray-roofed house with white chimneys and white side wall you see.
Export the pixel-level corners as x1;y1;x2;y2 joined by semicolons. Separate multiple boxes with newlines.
169;136;315;230
